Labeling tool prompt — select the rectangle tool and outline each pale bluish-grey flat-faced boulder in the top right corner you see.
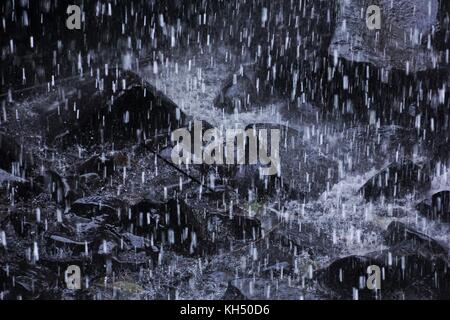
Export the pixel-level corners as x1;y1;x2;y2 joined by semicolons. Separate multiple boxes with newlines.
329;0;439;72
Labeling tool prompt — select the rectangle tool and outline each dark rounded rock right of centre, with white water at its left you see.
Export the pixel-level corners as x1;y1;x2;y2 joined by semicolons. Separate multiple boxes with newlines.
360;160;431;201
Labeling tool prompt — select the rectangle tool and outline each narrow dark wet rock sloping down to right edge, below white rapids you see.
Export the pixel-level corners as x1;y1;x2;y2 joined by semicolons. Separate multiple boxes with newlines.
385;221;448;256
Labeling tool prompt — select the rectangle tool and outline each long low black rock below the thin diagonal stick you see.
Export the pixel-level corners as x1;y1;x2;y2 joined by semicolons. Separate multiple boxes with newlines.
71;196;210;255
